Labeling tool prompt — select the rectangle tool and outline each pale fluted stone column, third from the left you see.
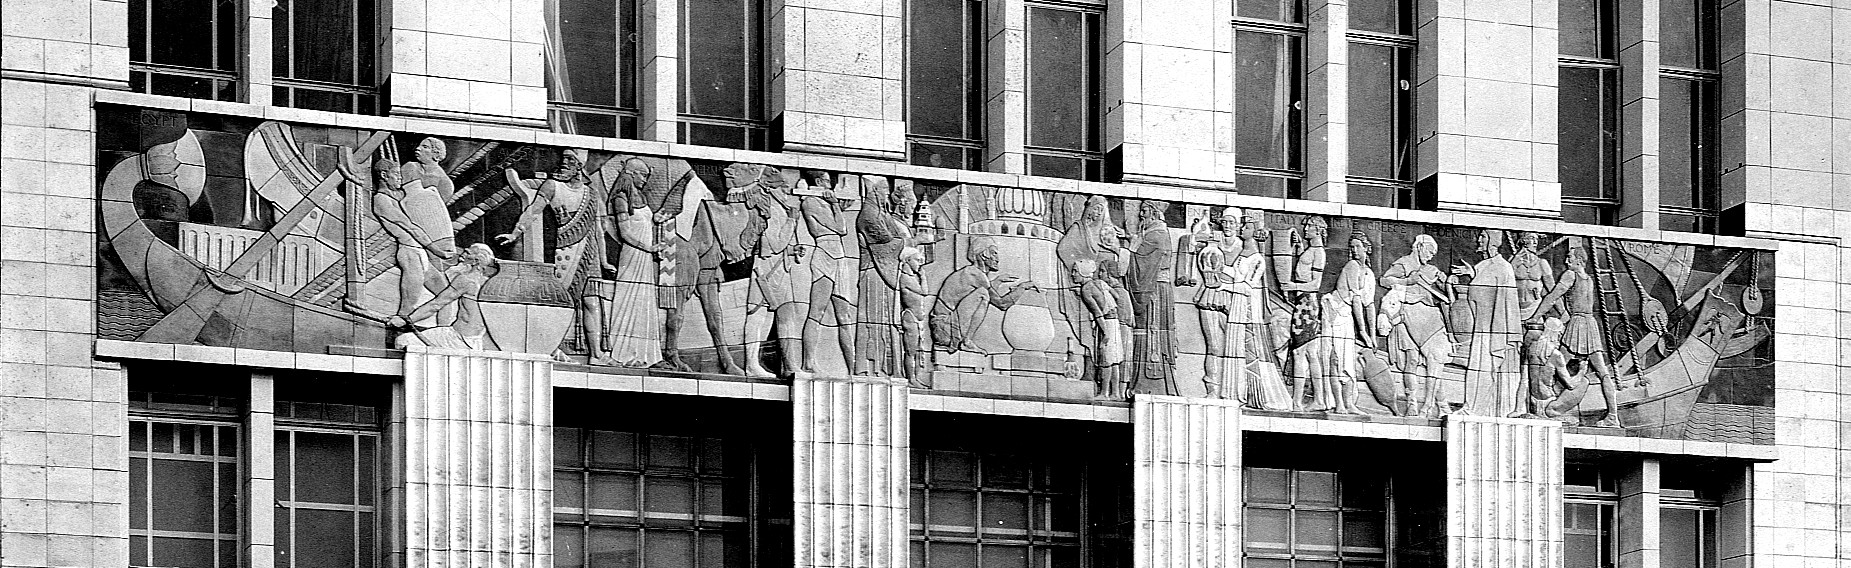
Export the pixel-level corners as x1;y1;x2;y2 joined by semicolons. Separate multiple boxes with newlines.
1131;394;1242;568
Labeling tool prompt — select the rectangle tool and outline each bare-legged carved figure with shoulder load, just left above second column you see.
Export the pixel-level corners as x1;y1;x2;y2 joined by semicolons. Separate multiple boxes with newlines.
722;163;809;377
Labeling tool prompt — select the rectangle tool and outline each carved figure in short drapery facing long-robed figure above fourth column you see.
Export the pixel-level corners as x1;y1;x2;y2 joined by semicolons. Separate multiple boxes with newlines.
1381;235;1453;418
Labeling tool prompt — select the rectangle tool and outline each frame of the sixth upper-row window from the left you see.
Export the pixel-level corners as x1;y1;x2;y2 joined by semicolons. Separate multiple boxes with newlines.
1022;0;1107;181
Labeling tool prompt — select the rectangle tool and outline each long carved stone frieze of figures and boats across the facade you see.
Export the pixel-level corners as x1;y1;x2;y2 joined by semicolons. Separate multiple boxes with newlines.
98;105;1773;442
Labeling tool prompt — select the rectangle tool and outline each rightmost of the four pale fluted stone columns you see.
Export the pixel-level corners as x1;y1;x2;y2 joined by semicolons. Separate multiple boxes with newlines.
1446;414;1562;568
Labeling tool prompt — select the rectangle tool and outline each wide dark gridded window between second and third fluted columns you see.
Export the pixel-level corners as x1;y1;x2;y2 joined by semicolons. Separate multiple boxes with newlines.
909;413;1131;568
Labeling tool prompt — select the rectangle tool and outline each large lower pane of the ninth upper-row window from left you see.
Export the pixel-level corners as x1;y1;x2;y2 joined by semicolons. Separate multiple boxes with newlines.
1557;67;1620;200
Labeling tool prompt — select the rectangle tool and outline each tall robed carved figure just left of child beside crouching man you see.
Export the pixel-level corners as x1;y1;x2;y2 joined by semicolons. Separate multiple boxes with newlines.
850;178;924;376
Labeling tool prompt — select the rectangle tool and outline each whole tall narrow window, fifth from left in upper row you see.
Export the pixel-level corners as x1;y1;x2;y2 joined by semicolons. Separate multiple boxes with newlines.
907;0;985;170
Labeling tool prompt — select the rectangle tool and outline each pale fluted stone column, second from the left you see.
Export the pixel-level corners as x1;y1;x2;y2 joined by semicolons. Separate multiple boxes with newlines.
790;377;911;568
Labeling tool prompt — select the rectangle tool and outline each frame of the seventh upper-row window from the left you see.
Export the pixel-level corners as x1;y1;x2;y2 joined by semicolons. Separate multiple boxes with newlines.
1231;0;1311;200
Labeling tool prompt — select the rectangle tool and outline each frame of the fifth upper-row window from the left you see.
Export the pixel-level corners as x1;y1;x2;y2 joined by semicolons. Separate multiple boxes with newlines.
905;0;996;170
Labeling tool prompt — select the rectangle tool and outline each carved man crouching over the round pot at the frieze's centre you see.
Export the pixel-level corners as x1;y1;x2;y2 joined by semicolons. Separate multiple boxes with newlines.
931;237;1040;352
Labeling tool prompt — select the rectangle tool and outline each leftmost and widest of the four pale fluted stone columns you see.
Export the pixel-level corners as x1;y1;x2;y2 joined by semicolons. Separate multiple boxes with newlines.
394;348;553;568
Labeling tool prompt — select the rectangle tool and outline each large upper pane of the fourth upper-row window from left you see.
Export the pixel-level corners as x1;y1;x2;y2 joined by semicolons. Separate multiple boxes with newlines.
681;0;759;120
